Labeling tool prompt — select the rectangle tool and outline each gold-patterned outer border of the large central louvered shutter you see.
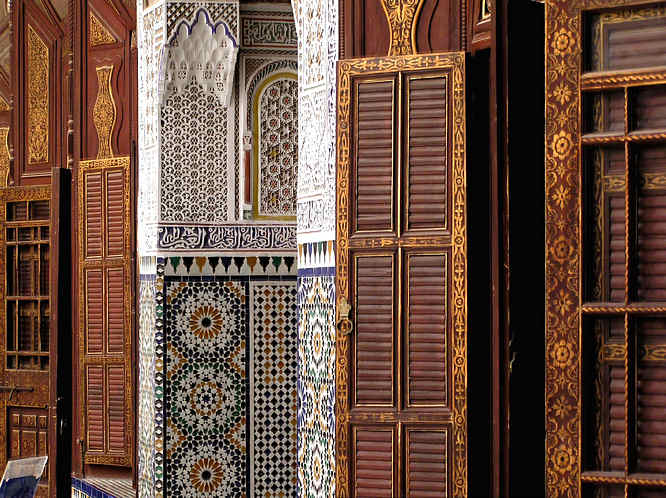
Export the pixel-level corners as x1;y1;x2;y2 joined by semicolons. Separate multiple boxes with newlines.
335;52;468;498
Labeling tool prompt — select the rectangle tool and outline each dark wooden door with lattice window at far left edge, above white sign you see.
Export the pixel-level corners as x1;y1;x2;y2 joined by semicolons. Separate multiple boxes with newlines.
0;187;56;496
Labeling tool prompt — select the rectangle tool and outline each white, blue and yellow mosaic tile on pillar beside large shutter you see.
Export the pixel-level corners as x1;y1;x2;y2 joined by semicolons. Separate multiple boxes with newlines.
298;269;335;498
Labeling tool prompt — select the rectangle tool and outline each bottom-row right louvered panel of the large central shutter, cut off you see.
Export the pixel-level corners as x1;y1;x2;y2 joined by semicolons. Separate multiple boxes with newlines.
406;429;448;498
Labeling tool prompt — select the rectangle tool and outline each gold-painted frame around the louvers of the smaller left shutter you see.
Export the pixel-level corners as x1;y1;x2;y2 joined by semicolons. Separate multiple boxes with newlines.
77;157;135;467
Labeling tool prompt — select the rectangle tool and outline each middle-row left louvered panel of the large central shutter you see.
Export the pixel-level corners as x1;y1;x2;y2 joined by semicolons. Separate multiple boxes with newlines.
355;255;395;406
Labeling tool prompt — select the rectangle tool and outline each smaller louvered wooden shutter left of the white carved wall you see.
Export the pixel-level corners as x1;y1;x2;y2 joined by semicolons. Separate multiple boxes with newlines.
78;157;134;466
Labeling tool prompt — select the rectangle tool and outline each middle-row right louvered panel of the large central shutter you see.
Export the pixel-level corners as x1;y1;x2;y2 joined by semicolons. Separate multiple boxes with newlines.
407;253;447;406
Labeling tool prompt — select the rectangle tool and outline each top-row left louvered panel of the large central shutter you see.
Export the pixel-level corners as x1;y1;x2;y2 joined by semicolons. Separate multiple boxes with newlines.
354;80;395;231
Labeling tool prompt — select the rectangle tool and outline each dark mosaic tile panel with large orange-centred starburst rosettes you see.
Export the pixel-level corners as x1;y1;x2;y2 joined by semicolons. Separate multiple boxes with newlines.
165;281;248;497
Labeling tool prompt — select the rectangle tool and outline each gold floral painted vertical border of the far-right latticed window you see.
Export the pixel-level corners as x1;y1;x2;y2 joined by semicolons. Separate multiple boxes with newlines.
544;0;654;497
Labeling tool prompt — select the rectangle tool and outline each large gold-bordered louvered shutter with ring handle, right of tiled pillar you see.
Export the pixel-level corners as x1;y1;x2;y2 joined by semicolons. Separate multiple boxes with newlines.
336;53;467;497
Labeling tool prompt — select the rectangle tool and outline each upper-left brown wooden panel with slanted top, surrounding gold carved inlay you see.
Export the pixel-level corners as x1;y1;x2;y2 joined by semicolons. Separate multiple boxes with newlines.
11;1;64;185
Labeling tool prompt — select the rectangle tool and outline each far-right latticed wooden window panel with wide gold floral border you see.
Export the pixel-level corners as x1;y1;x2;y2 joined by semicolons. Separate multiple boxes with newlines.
545;0;666;497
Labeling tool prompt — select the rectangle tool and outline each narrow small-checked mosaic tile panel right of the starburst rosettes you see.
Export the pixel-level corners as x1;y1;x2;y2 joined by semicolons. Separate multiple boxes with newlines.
250;281;298;497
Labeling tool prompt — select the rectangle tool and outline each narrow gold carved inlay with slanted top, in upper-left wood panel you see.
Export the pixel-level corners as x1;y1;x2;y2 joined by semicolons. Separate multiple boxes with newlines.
27;25;49;164
